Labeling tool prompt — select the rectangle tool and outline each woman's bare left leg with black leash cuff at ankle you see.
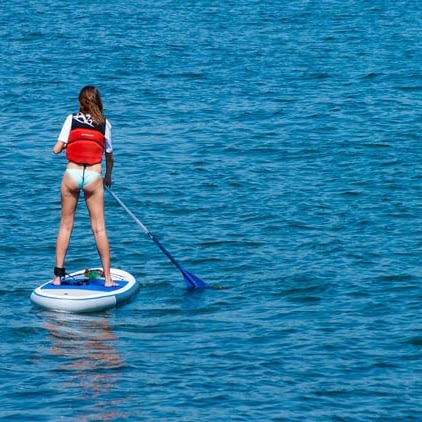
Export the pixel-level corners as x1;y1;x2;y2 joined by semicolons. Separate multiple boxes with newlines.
53;173;79;285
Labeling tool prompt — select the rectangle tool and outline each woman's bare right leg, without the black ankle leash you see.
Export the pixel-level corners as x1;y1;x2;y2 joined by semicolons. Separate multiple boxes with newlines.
84;178;118;287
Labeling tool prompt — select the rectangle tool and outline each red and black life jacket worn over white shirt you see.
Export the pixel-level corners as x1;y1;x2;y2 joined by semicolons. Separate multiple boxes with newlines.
66;113;105;164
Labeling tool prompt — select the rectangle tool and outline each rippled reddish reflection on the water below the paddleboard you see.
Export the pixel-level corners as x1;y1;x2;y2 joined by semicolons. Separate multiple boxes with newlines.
43;312;126;420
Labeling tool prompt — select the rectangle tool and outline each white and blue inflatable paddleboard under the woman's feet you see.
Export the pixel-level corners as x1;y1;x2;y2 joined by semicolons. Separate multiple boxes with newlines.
31;268;139;312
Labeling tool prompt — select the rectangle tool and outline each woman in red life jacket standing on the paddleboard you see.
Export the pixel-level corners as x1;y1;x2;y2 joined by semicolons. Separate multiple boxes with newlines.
53;86;116;287
